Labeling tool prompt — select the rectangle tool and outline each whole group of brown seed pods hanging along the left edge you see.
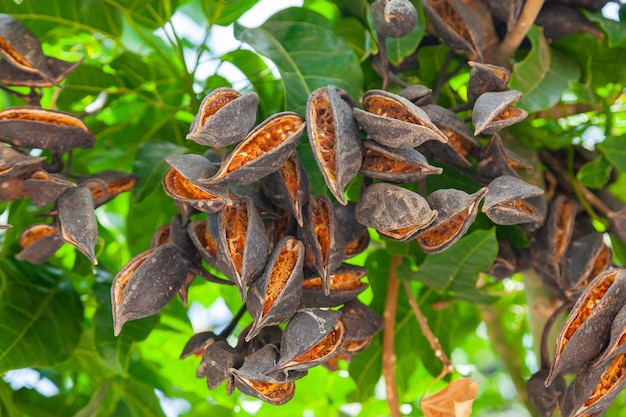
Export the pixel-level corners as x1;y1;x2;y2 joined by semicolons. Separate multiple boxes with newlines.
0;14;137;264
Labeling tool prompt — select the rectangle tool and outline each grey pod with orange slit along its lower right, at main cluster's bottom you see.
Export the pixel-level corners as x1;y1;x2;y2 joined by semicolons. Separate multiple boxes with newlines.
271;308;346;375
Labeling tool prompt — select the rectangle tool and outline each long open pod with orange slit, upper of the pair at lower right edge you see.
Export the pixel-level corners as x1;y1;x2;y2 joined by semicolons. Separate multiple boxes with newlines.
546;269;626;386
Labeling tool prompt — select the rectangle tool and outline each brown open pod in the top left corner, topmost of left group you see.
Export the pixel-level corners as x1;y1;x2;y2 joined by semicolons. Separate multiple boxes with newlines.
0;13;57;85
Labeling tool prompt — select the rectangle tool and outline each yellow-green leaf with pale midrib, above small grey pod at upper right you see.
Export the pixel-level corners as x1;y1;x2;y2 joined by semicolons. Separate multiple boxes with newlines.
509;26;580;113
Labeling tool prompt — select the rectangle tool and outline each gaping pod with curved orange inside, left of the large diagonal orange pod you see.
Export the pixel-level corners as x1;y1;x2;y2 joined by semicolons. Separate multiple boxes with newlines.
163;154;231;213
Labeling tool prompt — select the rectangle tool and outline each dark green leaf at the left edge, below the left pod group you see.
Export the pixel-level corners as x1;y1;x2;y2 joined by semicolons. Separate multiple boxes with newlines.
0;259;83;374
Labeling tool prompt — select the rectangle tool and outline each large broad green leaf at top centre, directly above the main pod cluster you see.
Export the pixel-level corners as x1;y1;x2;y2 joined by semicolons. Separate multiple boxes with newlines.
235;8;363;115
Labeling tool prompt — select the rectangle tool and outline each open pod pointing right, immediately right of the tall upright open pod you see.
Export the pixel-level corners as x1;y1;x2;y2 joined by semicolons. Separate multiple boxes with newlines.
352;90;448;148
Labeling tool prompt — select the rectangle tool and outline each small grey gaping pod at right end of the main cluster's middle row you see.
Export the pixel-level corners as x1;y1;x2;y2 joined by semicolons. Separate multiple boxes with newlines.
482;175;543;225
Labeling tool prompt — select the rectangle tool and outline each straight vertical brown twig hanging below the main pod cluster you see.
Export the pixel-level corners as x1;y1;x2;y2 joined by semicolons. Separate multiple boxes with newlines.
383;255;402;417
